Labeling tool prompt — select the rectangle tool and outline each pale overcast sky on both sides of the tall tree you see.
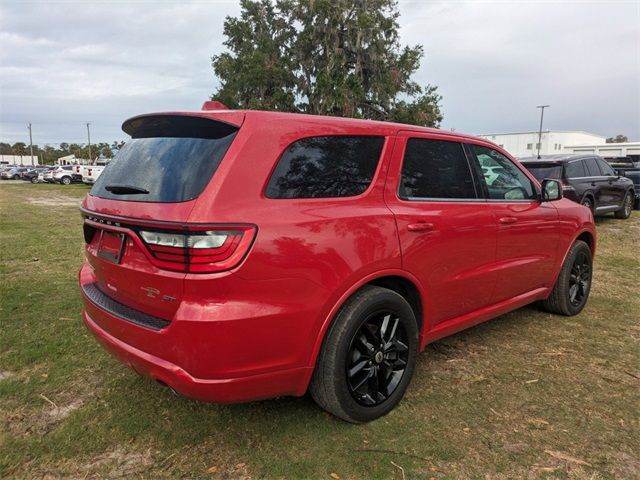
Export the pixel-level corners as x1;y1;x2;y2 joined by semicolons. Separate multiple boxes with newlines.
0;0;640;145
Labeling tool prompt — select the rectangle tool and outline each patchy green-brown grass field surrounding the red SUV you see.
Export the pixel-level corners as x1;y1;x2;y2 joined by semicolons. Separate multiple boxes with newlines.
0;182;640;479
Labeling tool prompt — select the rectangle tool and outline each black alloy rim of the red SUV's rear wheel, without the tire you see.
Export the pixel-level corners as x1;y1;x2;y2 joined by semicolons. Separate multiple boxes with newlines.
346;311;409;406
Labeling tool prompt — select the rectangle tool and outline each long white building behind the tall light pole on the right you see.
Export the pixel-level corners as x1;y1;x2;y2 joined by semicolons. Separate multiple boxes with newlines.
478;130;611;158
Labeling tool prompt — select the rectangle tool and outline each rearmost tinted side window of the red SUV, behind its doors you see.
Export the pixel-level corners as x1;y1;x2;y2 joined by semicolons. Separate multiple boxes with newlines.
266;136;384;198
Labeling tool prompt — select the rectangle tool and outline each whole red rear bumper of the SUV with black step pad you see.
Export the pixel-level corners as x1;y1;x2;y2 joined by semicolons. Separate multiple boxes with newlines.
79;256;312;403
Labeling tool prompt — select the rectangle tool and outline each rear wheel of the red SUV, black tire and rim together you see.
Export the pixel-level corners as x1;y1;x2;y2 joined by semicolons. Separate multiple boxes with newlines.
309;286;418;423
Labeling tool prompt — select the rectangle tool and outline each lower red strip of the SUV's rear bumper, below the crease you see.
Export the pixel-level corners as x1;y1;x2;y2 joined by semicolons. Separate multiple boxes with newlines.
83;311;310;403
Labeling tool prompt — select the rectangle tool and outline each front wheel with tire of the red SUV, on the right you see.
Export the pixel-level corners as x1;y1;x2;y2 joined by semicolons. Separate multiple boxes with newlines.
541;240;593;317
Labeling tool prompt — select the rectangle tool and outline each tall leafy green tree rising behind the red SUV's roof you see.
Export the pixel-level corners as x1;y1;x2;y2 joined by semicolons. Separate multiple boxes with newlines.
211;0;442;126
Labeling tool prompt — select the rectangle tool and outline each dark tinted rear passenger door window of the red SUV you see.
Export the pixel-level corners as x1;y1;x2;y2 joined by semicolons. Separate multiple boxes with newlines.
398;138;478;200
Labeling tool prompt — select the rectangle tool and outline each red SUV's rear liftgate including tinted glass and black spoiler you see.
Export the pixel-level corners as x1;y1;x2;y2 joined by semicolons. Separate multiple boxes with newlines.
82;114;242;321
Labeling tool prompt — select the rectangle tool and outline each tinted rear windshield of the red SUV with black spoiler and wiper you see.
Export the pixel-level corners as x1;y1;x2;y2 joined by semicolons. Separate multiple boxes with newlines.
90;115;238;203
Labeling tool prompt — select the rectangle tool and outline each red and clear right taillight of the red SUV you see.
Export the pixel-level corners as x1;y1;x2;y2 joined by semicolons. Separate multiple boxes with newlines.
138;226;256;273
